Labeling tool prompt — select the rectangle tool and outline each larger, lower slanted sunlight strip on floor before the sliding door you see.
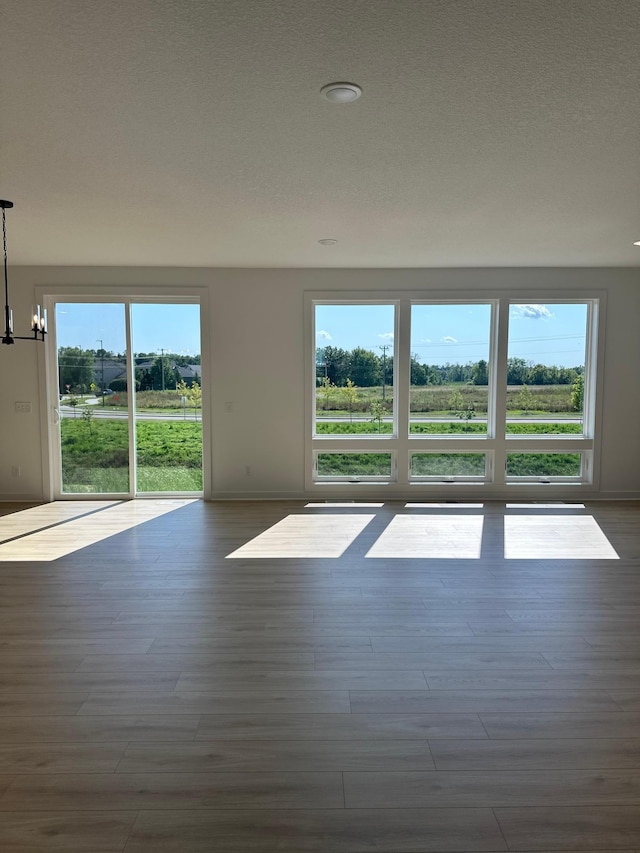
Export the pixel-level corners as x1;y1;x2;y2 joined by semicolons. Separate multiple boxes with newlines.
0;499;196;562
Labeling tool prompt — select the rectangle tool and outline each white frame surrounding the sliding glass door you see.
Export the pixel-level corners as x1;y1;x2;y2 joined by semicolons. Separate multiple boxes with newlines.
35;285;212;501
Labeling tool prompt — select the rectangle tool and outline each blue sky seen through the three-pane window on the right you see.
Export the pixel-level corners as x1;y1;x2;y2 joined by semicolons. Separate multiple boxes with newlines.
316;304;587;367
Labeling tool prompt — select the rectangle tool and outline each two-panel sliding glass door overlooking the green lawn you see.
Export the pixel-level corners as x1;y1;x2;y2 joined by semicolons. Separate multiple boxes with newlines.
50;300;203;497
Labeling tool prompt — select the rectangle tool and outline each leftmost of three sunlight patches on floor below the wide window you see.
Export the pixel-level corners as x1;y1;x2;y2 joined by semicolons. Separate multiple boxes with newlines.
227;513;375;559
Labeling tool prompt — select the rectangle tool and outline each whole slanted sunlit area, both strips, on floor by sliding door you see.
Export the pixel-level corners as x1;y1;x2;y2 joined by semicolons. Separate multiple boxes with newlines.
0;499;198;562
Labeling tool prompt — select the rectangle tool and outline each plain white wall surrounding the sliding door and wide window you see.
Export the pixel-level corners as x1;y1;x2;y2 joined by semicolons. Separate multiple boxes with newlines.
0;267;640;500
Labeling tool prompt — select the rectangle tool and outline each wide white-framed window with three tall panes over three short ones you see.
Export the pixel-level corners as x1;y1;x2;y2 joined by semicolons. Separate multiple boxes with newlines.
307;293;601;494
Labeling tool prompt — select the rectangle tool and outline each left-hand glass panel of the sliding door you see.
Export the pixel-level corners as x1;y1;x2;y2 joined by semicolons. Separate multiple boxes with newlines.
55;302;131;495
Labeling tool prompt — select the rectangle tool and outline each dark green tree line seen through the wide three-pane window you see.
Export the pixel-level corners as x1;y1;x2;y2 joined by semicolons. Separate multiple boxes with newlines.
316;346;584;388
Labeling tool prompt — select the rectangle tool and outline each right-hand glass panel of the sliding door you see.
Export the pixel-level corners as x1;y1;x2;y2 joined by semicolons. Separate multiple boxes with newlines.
131;302;203;494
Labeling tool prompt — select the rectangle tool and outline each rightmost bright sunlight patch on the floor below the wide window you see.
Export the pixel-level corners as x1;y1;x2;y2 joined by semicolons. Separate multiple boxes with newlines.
504;515;620;560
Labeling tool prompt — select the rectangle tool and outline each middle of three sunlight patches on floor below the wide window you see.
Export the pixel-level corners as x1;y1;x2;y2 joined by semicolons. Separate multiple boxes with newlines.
367;515;484;560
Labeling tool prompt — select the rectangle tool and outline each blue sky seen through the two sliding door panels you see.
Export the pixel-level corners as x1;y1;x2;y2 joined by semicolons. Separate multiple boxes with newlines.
56;303;200;355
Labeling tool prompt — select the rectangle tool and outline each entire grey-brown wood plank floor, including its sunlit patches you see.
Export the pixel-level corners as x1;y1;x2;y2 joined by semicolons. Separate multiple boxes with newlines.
0;501;640;853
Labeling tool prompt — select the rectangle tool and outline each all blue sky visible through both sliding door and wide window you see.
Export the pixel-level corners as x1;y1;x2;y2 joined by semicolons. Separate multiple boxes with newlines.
56;303;587;367
